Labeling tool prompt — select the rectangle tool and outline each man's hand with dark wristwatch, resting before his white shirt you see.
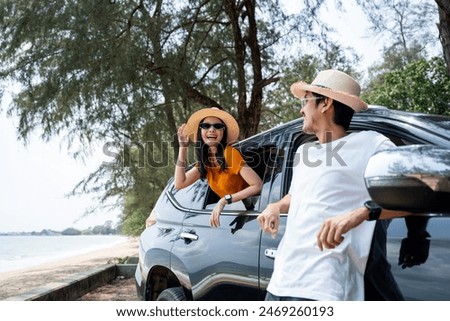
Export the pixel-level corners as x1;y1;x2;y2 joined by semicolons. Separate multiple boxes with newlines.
317;207;368;251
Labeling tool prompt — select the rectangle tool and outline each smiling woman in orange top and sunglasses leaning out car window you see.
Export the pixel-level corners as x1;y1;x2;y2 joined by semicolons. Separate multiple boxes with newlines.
174;107;262;227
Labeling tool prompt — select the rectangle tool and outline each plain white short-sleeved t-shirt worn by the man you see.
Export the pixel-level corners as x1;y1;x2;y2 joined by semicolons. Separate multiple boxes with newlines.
268;131;395;301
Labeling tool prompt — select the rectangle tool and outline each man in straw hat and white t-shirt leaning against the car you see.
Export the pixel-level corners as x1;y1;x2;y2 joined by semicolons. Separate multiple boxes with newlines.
258;70;406;300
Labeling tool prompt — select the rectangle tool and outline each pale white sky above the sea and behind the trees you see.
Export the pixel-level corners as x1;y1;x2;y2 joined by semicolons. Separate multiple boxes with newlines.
0;0;426;232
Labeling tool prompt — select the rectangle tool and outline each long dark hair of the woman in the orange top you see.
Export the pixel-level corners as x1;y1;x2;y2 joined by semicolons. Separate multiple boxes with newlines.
195;120;227;179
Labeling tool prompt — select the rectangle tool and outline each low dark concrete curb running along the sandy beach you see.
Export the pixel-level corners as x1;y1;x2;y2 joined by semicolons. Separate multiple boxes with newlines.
4;264;136;301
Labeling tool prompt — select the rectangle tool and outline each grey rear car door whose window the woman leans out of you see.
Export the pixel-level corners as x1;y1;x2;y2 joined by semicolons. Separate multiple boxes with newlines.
172;141;282;300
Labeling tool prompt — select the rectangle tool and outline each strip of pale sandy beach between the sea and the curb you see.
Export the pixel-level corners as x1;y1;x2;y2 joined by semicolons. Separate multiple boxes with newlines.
0;238;139;300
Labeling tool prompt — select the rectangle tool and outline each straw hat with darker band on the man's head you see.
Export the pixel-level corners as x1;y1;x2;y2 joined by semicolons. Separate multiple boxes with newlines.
291;69;367;112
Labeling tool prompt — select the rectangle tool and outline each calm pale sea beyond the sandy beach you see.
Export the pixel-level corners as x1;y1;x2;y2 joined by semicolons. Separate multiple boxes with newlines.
0;235;128;273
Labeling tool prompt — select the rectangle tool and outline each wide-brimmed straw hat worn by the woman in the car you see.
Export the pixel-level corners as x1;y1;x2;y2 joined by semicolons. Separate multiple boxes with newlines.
185;107;239;144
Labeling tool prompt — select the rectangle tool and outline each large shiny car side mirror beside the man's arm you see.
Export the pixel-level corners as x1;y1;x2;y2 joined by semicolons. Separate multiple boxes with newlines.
364;145;450;215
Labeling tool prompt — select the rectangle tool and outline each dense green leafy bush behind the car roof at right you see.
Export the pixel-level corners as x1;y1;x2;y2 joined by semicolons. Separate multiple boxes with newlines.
363;57;450;115
